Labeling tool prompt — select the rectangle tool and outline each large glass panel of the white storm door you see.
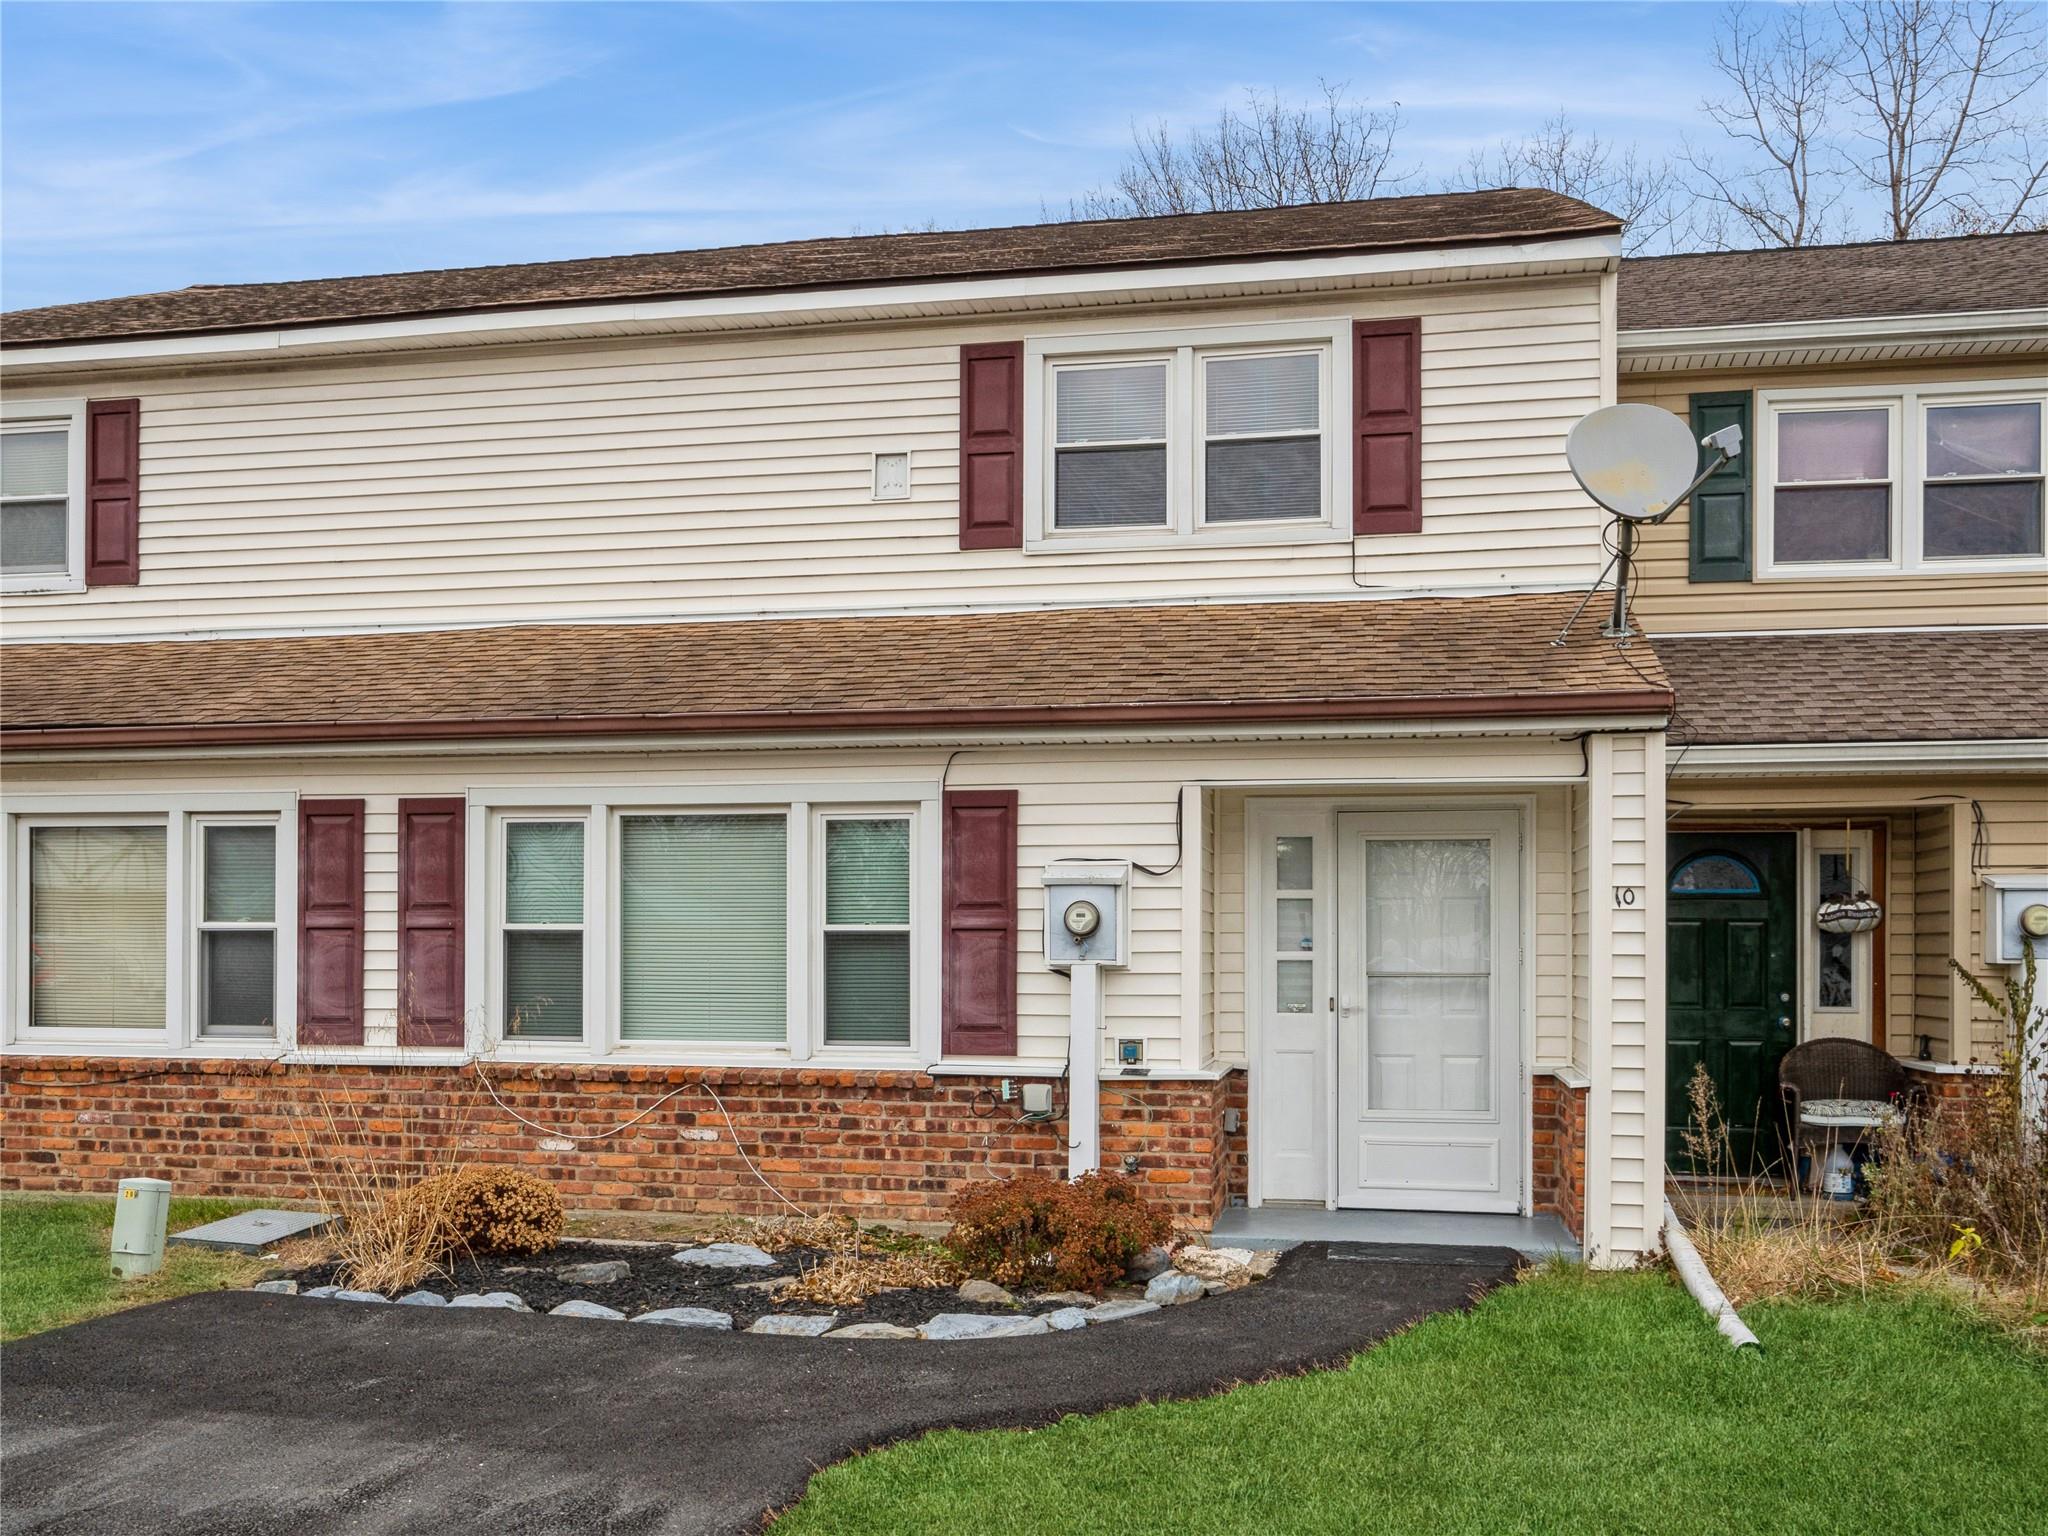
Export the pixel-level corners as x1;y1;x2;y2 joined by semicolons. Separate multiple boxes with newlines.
1366;838;1493;1114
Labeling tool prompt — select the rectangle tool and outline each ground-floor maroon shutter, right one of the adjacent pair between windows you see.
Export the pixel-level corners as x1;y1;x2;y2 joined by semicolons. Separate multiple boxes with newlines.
397;799;467;1044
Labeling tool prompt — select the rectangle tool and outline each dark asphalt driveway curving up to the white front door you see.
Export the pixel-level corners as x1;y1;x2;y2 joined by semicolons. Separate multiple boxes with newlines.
0;1245;1518;1536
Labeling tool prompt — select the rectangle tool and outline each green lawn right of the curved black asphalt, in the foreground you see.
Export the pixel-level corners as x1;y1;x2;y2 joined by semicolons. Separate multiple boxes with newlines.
774;1268;2048;1536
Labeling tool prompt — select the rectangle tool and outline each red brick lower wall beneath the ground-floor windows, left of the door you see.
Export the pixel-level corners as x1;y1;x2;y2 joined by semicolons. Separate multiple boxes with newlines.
0;1057;1245;1231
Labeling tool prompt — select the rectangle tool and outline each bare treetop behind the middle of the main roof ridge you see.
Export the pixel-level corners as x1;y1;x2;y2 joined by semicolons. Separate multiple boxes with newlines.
1053;80;1415;219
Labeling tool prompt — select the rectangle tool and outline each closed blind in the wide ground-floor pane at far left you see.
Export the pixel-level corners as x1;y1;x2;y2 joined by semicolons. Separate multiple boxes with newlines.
29;827;164;1030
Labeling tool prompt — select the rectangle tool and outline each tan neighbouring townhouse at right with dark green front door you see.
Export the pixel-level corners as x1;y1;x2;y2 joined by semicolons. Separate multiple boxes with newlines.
1620;233;2048;1179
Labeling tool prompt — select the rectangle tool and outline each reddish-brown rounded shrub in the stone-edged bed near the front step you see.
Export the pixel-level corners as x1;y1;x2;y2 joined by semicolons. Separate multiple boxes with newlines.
946;1174;1174;1290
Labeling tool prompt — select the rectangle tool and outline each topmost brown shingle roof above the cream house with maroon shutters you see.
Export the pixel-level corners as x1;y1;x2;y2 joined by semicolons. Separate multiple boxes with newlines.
0;188;1622;346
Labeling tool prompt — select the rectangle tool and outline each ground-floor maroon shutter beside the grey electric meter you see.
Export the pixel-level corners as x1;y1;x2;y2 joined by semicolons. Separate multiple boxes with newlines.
942;788;1018;1057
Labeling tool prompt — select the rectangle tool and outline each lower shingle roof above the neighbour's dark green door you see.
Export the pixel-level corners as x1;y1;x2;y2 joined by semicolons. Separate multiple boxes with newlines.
1655;629;2048;745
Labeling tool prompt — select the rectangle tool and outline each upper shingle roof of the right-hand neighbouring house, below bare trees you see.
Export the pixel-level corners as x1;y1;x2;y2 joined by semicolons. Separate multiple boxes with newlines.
1620;233;2048;330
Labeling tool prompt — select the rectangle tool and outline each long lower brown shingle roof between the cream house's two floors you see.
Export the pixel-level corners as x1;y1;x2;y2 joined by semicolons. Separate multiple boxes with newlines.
0;594;1669;748
